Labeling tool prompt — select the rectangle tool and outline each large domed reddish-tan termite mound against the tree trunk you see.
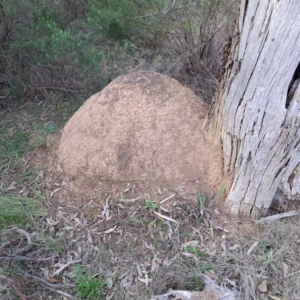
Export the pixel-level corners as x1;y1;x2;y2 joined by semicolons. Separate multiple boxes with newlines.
58;71;222;184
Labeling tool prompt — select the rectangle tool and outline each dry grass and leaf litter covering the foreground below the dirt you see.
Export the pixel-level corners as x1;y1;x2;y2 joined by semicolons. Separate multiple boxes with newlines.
0;182;300;299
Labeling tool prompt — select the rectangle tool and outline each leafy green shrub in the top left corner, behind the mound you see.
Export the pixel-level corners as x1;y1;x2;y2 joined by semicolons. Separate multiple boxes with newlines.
0;0;127;100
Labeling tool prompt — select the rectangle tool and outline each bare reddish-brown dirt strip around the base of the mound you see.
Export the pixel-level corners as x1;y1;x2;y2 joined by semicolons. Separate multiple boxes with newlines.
29;131;254;247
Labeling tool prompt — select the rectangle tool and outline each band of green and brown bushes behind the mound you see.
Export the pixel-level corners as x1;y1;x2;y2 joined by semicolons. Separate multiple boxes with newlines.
0;0;234;105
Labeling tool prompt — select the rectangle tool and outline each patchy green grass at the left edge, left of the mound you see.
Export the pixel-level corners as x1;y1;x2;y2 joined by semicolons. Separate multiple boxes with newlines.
0;99;81;228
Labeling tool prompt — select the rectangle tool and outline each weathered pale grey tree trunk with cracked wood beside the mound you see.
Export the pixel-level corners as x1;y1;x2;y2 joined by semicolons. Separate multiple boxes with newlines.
206;0;300;218
